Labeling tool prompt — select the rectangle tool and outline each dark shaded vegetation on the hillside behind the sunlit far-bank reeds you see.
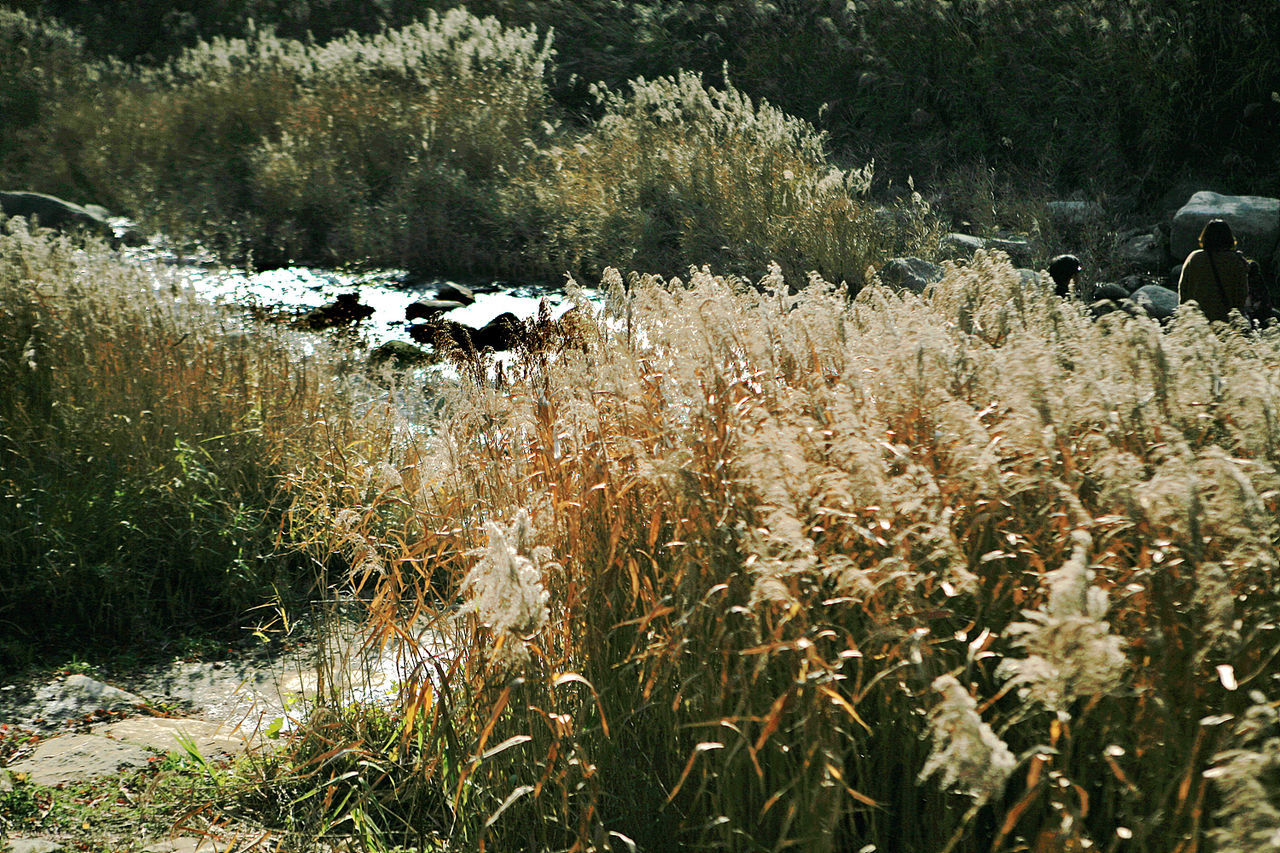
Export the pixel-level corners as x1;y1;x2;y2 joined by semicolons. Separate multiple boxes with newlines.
10;0;1280;204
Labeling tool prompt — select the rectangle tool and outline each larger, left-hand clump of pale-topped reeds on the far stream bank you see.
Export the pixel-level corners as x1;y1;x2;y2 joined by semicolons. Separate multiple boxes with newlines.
3;12;548;273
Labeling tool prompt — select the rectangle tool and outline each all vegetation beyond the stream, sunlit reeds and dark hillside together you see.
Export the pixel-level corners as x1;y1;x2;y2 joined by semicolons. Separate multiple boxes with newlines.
0;0;1280;281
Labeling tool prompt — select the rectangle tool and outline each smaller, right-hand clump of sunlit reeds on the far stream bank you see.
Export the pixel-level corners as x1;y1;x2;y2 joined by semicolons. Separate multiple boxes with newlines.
509;73;929;287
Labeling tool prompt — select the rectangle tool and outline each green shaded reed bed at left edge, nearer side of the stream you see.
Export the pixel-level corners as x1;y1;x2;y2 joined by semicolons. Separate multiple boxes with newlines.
0;220;381;670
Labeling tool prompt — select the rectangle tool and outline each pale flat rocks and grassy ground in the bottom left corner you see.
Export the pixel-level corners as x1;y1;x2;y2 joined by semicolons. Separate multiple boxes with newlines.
0;625;450;853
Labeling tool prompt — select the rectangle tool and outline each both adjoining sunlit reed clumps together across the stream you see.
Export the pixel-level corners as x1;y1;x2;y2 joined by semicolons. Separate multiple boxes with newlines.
0;10;928;283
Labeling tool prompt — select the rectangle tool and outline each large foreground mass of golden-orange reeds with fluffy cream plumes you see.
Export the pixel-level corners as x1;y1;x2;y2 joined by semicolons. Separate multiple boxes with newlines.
254;254;1280;853
